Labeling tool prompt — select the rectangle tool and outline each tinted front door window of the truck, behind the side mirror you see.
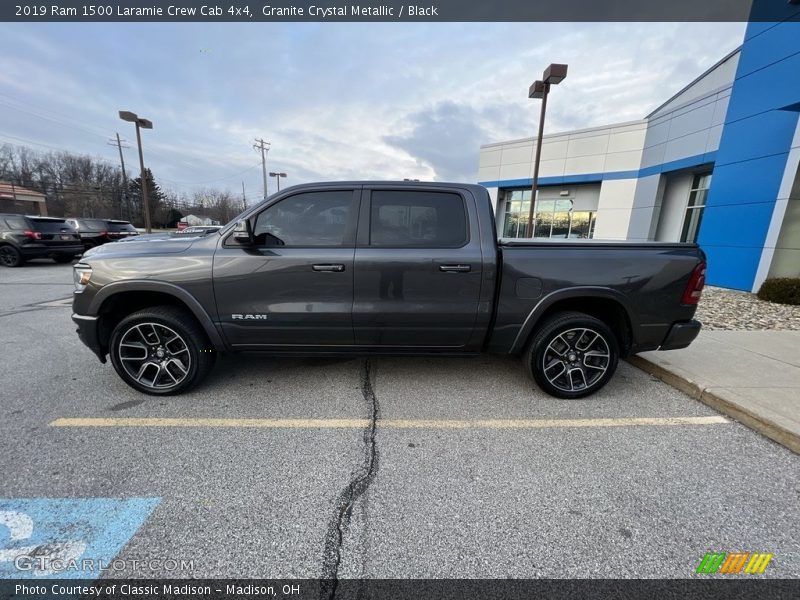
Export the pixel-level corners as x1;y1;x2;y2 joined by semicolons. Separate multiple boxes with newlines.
253;190;354;246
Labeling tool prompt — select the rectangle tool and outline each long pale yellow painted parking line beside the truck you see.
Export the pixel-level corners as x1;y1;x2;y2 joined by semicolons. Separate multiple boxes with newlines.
50;415;730;429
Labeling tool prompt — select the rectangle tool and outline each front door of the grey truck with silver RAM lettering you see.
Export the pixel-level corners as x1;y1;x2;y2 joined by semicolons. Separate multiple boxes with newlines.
214;186;360;350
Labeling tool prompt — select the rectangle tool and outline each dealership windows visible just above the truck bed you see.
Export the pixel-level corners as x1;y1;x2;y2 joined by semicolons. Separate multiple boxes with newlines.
502;190;595;239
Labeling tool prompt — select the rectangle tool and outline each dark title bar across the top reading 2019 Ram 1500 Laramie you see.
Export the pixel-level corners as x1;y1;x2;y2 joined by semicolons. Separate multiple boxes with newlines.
0;0;800;22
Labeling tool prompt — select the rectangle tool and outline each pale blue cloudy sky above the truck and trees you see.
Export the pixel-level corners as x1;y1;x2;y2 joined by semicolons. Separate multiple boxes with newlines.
0;23;744;197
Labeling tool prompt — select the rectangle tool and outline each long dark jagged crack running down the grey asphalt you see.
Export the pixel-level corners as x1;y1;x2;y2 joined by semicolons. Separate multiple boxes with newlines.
320;359;380;600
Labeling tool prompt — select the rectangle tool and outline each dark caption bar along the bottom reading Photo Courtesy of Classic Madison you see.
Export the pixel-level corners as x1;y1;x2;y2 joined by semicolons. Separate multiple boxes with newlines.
0;575;800;600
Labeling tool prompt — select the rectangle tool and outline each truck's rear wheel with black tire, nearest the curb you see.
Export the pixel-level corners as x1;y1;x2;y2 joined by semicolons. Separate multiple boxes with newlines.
525;312;619;399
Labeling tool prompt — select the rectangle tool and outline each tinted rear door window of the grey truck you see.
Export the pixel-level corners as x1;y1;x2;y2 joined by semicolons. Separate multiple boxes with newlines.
370;190;469;248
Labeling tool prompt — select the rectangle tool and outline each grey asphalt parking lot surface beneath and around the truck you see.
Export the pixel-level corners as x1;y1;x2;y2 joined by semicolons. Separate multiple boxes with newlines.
0;261;800;578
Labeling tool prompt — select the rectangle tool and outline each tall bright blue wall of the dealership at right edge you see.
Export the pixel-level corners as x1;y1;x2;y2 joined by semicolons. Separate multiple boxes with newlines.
698;5;800;291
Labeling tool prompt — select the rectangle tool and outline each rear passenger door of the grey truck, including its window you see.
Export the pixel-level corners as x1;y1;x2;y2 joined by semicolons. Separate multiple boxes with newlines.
353;185;483;350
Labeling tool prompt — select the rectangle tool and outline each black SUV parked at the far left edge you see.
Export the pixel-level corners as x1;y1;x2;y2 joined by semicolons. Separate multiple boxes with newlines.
0;214;83;267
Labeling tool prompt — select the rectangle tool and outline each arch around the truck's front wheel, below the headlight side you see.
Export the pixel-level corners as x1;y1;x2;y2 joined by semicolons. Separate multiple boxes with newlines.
89;280;225;352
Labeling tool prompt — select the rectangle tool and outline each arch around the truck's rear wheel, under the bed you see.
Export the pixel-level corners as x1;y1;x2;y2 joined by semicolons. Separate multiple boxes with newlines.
511;287;637;356
